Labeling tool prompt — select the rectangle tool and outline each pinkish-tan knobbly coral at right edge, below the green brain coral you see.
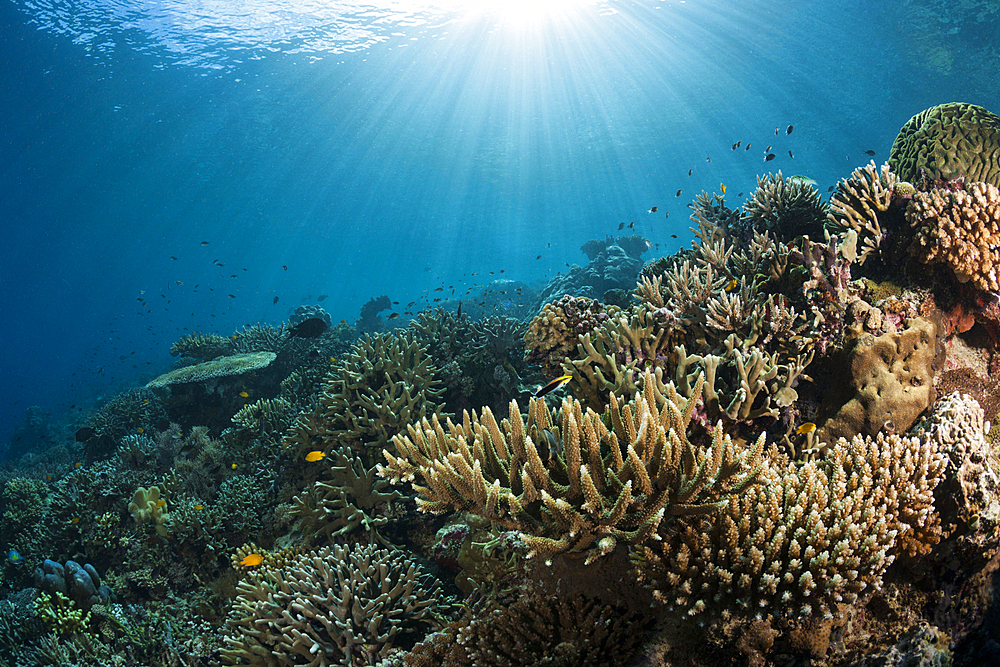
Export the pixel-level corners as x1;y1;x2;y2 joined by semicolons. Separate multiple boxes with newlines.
906;183;1000;292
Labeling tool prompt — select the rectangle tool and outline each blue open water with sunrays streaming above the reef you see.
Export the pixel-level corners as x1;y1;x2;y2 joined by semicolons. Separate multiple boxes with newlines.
0;0;1000;454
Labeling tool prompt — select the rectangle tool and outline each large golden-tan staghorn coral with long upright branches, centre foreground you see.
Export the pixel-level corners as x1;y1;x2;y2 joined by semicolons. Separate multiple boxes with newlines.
378;370;764;563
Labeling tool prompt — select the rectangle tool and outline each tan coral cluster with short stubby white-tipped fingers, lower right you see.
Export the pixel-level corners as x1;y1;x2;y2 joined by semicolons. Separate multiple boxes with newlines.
635;434;945;619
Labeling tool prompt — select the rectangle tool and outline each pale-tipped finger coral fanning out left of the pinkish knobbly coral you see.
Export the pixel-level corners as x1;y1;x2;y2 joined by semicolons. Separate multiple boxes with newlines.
827;160;902;264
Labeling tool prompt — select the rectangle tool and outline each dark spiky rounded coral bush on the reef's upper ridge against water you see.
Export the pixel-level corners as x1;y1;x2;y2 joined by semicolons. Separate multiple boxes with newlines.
742;170;826;241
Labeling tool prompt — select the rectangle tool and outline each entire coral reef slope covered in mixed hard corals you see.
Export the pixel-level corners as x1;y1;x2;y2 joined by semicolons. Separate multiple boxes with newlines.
0;104;1000;666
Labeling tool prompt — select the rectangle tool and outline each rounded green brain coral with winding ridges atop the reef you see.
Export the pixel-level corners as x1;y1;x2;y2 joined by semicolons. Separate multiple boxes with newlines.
889;102;1000;185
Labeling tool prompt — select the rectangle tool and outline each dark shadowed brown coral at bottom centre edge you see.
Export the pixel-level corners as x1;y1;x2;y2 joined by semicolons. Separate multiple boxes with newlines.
402;596;650;667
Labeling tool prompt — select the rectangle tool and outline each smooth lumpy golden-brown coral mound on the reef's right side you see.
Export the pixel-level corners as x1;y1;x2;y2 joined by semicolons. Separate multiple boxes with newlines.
819;317;944;442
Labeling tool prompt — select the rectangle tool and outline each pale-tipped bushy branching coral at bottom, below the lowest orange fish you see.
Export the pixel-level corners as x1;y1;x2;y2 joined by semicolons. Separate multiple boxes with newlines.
222;545;447;667
